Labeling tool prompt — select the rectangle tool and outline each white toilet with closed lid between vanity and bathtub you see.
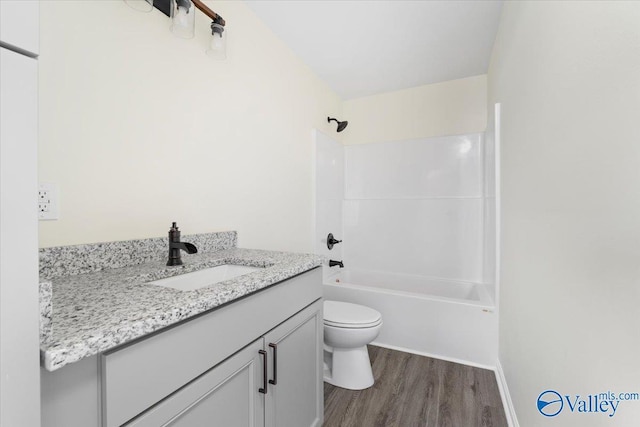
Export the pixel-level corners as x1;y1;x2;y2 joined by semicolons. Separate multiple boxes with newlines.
324;301;382;390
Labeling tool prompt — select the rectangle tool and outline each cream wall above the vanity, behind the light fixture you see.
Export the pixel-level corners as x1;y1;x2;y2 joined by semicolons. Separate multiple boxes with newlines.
39;0;342;251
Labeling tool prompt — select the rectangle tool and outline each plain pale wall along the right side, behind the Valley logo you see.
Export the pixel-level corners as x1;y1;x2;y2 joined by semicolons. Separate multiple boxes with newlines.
489;2;640;427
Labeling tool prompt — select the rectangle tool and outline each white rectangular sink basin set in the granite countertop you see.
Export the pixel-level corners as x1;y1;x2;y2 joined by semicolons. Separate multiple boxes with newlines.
148;264;262;291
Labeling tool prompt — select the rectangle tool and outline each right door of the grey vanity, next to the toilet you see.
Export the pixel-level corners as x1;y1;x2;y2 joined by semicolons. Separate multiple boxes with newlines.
265;300;324;427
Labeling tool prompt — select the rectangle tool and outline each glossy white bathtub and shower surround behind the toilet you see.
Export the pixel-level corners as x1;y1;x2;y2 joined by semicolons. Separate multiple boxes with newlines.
315;132;498;367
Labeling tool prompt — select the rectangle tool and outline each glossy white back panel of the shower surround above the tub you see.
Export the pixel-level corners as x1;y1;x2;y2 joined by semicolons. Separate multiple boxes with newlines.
343;134;483;282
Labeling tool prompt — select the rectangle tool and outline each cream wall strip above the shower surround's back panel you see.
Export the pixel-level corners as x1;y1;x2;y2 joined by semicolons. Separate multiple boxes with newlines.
340;75;487;144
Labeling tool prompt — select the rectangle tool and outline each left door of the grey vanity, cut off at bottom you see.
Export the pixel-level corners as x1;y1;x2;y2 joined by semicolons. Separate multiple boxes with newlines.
126;338;264;427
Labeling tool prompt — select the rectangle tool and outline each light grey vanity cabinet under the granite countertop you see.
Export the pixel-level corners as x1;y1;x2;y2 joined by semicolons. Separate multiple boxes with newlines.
41;268;324;427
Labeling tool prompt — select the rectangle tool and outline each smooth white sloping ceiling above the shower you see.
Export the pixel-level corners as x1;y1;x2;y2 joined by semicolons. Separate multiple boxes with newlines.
246;0;502;99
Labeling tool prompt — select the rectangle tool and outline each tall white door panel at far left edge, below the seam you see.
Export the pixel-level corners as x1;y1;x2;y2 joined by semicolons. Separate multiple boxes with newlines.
0;48;40;426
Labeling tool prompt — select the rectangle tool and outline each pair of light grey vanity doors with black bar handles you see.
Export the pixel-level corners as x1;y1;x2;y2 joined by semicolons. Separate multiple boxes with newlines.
126;301;322;427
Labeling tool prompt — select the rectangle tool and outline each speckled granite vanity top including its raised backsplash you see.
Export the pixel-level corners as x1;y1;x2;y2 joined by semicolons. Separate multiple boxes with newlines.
40;232;323;371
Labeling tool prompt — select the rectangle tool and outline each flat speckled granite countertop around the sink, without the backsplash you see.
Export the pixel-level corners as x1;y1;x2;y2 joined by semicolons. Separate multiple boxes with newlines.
40;246;324;371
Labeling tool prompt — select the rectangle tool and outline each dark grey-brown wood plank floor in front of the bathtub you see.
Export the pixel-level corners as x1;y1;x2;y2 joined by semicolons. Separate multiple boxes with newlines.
324;346;507;427
